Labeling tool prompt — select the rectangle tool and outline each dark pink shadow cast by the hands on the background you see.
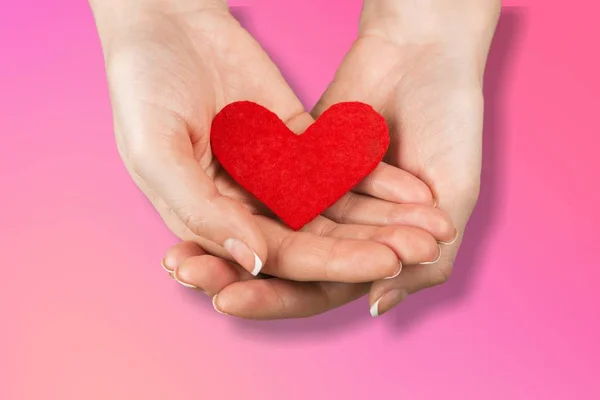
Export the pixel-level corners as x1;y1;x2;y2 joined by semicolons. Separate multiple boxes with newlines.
218;7;526;340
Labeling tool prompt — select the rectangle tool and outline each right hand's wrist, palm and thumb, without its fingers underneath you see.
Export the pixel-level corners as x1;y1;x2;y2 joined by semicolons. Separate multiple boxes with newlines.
313;0;500;316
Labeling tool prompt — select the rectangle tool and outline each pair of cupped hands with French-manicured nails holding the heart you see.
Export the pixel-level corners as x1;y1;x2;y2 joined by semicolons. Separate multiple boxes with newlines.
91;0;499;319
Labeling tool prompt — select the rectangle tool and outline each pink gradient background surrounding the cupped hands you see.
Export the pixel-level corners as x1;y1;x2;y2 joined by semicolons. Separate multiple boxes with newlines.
0;0;600;400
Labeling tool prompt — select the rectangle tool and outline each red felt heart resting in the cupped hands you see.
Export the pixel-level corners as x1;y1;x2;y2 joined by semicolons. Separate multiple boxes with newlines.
210;101;390;230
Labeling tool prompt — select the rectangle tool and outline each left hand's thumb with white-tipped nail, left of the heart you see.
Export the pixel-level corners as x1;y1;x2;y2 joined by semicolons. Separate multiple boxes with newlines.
128;135;267;275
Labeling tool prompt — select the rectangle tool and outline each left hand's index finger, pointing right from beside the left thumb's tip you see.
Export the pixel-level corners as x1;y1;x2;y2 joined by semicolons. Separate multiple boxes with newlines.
256;216;401;283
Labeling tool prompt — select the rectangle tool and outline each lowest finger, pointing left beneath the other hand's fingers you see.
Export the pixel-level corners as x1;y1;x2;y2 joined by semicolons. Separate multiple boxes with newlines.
213;279;369;319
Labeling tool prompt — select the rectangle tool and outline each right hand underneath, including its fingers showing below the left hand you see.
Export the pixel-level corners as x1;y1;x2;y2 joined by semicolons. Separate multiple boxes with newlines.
157;0;500;319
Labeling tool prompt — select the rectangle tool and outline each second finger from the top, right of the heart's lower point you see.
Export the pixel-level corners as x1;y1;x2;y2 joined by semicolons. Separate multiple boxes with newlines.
323;192;456;242
